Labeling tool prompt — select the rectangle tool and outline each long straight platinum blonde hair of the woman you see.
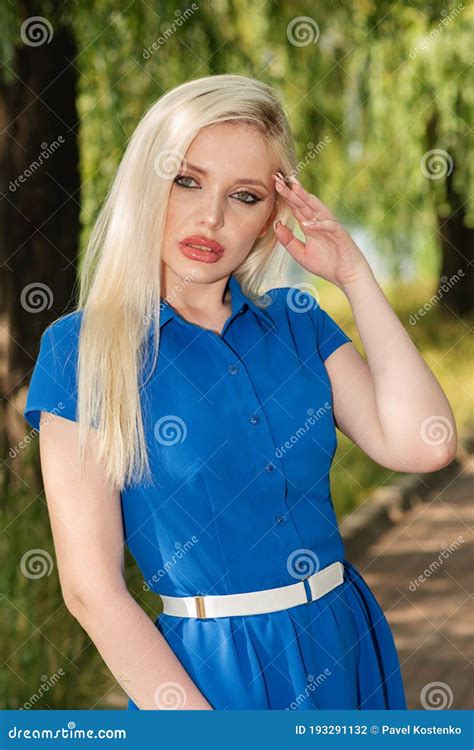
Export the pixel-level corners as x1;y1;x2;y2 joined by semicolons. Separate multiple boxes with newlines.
77;75;297;490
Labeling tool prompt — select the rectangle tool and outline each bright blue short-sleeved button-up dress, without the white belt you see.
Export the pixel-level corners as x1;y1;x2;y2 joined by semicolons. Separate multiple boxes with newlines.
24;275;406;710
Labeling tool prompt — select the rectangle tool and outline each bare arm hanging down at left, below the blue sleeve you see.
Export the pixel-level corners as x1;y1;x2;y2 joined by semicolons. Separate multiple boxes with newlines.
40;412;212;710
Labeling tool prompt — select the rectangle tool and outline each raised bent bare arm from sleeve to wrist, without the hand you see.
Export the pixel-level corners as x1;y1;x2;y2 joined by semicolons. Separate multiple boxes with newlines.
325;269;457;472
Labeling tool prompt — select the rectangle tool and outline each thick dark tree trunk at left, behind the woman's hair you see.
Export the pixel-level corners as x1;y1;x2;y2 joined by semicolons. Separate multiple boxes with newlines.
0;0;80;488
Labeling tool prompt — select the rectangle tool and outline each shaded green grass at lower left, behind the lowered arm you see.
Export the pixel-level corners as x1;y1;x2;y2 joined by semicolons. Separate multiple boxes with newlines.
0;440;156;710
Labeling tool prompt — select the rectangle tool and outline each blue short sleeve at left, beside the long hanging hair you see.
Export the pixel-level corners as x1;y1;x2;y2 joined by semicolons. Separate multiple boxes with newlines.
23;313;79;430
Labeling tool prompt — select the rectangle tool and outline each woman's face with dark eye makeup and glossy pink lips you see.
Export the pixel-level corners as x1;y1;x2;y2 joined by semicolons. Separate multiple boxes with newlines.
162;123;277;290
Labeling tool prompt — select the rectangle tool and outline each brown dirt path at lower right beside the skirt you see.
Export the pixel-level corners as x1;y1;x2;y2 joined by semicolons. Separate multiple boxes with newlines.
350;454;474;709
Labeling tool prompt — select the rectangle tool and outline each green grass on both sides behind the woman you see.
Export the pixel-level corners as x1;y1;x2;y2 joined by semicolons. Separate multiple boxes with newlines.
5;284;473;709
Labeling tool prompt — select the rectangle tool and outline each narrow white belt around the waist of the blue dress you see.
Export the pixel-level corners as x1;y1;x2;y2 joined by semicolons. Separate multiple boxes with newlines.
160;562;344;619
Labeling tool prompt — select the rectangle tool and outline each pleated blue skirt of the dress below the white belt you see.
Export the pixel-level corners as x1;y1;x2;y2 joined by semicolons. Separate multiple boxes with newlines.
127;560;407;710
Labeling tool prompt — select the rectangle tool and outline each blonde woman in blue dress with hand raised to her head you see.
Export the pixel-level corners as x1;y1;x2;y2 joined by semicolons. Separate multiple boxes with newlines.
25;75;456;710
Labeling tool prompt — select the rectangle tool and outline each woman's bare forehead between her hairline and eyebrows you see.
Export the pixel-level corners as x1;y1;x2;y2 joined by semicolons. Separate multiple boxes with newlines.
184;122;274;178
